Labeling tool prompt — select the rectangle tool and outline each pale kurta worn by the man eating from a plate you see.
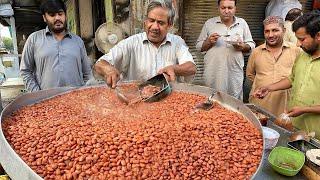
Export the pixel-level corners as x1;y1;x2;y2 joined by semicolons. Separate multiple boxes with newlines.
196;16;255;99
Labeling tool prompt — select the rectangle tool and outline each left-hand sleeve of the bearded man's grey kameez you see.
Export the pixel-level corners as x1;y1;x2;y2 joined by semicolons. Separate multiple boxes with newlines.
20;35;41;92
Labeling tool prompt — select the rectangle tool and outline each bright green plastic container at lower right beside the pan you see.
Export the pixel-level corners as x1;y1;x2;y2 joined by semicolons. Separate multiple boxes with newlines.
268;146;305;176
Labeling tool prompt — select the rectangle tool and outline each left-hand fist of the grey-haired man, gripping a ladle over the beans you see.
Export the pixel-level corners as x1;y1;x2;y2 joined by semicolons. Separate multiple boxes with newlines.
94;60;120;88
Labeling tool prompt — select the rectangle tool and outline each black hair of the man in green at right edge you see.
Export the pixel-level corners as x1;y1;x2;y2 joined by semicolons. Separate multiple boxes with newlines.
292;10;320;38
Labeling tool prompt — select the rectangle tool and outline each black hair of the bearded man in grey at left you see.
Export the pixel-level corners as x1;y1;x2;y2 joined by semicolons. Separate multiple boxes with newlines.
40;0;67;15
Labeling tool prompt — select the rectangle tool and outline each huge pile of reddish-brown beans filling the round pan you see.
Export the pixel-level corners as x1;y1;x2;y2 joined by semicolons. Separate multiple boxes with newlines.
3;87;263;179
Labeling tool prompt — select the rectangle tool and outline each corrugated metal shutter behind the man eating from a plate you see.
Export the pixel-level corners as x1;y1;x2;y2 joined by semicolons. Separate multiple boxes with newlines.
182;0;312;84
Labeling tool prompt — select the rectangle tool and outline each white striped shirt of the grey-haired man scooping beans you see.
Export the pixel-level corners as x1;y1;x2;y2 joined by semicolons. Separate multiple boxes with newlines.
98;32;194;81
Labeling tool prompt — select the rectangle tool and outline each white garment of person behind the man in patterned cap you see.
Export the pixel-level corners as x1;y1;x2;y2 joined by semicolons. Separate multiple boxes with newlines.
265;0;302;20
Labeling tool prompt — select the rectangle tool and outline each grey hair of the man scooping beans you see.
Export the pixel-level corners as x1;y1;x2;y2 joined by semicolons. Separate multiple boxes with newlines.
147;0;176;25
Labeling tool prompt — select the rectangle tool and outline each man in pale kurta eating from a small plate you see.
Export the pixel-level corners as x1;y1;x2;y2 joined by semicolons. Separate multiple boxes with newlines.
196;0;255;99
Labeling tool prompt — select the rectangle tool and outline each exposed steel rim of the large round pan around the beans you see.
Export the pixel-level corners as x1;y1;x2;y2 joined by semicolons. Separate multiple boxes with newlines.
0;83;265;180
